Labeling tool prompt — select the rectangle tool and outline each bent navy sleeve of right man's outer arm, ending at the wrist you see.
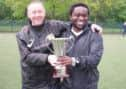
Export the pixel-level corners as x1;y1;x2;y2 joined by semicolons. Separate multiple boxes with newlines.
76;33;103;69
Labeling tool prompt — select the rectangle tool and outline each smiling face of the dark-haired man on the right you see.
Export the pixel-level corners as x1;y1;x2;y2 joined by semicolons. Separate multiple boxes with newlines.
70;6;88;29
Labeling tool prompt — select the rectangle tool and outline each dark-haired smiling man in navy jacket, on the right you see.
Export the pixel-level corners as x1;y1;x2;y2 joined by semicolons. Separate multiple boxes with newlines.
53;3;103;89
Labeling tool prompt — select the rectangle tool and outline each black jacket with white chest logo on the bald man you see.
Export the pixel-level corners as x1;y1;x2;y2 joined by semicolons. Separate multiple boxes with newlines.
16;21;64;89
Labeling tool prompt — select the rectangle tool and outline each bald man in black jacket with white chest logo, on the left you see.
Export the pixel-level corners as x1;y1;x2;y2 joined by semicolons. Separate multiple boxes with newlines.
16;1;101;89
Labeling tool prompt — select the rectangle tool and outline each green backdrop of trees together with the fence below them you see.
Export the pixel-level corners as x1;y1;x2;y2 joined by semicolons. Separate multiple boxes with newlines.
0;0;126;33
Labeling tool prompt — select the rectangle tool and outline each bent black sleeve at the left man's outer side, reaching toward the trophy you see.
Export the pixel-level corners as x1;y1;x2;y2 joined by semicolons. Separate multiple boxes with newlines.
16;33;48;66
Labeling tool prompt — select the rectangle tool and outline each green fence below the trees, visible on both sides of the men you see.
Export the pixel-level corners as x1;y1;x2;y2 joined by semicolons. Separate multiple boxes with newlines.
0;20;122;33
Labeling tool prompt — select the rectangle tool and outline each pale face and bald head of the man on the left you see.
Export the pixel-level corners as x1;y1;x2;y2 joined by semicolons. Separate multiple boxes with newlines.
27;3;46;26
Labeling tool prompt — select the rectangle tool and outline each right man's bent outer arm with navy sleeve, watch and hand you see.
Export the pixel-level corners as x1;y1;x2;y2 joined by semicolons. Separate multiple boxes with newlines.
59;33;103;69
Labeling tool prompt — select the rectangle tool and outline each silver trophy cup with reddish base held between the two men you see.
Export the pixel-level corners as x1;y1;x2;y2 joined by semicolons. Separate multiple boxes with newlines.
47;34;69;82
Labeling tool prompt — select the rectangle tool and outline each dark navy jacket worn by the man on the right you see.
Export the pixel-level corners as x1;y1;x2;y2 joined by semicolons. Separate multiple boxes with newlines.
62;25;103;89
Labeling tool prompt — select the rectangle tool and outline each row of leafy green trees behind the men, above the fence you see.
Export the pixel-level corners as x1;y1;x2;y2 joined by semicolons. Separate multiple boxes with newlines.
0;0;126;22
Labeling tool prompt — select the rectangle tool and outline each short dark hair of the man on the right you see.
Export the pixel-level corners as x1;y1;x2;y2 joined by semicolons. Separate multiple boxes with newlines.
69;3;90;15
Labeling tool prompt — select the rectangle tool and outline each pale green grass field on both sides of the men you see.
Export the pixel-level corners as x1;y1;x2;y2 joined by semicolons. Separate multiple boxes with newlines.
0;33;126;89
